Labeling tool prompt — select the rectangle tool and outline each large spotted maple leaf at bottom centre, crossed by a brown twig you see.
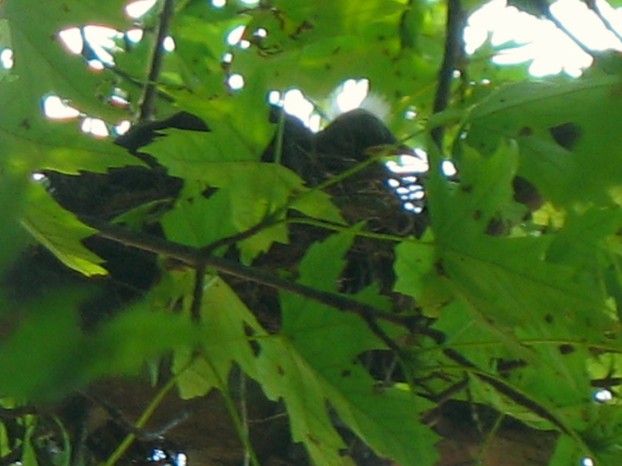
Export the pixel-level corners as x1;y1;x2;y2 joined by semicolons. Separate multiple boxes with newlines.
258;232;437;465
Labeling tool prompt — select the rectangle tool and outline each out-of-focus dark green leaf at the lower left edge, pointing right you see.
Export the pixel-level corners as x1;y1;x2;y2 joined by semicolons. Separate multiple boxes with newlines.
0;293;201;401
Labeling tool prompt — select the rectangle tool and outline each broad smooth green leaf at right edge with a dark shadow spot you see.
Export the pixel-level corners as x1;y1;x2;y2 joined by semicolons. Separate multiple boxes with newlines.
467;76;622;204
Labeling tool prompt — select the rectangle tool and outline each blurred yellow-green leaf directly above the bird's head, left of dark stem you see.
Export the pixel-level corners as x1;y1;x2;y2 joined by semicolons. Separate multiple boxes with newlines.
232;0;442;111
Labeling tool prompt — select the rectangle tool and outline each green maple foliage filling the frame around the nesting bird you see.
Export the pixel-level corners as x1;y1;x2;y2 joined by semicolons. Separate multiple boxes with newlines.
0;0;622;466
